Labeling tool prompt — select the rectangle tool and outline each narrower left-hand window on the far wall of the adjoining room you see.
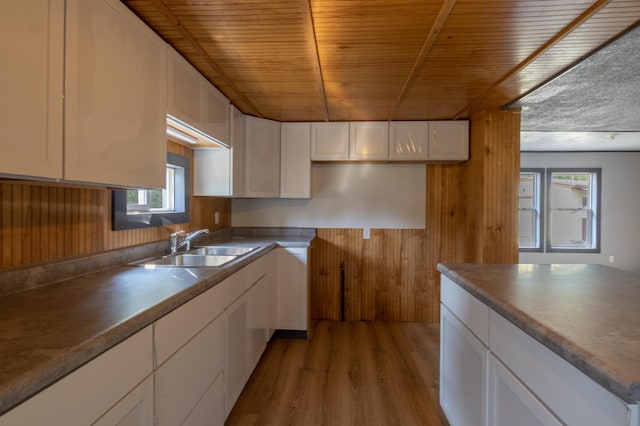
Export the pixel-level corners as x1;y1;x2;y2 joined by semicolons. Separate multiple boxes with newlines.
518;169;544;251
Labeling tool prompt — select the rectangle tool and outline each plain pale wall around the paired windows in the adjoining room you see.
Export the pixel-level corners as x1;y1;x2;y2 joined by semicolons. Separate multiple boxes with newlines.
520;152;640;272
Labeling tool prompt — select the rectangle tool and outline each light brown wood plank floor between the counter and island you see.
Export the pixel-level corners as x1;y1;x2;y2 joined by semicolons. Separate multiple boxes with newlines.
226;321;447;426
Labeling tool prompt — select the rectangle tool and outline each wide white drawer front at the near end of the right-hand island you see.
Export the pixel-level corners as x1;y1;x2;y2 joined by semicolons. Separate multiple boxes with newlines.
489;311;630;426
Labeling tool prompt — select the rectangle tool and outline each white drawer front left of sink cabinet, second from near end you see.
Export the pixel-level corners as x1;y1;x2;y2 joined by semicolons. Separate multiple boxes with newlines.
154;280;226;365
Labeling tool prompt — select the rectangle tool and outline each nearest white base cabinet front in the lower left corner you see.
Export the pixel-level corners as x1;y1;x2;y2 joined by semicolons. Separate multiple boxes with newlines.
0;326;153;426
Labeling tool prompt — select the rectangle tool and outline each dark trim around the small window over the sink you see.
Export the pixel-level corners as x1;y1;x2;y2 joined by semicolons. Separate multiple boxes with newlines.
112;152;191;231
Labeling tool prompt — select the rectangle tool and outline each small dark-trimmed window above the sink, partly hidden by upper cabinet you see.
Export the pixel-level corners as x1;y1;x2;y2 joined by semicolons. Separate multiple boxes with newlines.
113;153;189;230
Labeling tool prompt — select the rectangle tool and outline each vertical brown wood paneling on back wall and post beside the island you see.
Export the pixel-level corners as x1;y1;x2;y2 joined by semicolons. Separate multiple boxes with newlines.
311;109;520;322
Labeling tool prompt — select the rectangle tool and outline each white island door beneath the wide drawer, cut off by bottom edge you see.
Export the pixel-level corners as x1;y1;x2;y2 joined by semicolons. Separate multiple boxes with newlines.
489;356;562;426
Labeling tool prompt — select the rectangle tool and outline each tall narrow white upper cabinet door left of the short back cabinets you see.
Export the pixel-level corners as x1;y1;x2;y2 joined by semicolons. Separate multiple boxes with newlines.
280;123;311;198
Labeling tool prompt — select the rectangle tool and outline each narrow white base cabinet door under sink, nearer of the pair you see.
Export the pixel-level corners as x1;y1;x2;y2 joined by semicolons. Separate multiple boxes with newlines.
224;293;249;418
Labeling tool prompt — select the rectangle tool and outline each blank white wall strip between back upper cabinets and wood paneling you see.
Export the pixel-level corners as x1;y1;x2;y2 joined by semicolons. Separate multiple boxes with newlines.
231;164;426;229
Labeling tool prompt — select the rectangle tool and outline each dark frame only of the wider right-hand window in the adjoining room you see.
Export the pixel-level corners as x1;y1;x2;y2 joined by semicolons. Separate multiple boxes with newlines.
544;167;602;253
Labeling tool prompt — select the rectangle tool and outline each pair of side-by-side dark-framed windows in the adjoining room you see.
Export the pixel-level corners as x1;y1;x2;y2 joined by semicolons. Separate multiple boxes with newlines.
518;169;601;253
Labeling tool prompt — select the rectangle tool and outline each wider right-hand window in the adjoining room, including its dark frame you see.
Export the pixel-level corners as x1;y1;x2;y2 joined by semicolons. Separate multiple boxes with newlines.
547;169;600;253
